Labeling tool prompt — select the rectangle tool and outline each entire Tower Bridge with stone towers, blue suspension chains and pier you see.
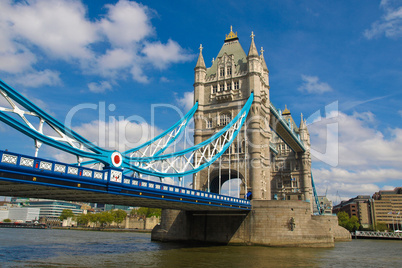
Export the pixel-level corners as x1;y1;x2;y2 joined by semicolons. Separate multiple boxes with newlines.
0;29;350;247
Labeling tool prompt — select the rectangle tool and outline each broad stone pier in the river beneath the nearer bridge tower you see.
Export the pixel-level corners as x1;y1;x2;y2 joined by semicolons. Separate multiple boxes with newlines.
152;200;348;247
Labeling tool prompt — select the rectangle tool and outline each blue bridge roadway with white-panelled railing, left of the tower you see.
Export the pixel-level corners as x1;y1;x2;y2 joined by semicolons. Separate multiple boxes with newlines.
0;151;251;212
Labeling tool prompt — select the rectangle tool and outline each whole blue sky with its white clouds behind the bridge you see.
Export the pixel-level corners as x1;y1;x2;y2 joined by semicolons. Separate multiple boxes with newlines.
0;0;402;201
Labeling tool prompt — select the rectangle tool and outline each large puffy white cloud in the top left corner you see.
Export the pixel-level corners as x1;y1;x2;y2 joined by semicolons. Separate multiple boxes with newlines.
8;0;98;59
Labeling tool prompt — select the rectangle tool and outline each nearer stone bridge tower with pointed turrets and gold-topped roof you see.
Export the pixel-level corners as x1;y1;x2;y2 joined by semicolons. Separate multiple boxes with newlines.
194;29;271;199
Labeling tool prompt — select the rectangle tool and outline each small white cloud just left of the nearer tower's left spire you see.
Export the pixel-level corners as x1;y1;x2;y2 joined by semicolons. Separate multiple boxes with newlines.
142;39;194;69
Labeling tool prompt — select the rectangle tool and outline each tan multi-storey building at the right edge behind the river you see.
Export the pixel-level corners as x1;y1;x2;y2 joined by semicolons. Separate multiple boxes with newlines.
373;187;402;230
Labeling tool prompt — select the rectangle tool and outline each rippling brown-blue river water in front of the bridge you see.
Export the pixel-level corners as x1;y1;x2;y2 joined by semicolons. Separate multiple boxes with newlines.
0;228;402;268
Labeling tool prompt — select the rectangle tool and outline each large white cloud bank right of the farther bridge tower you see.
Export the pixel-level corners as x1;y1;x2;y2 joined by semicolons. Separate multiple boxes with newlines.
308;109;402;201
